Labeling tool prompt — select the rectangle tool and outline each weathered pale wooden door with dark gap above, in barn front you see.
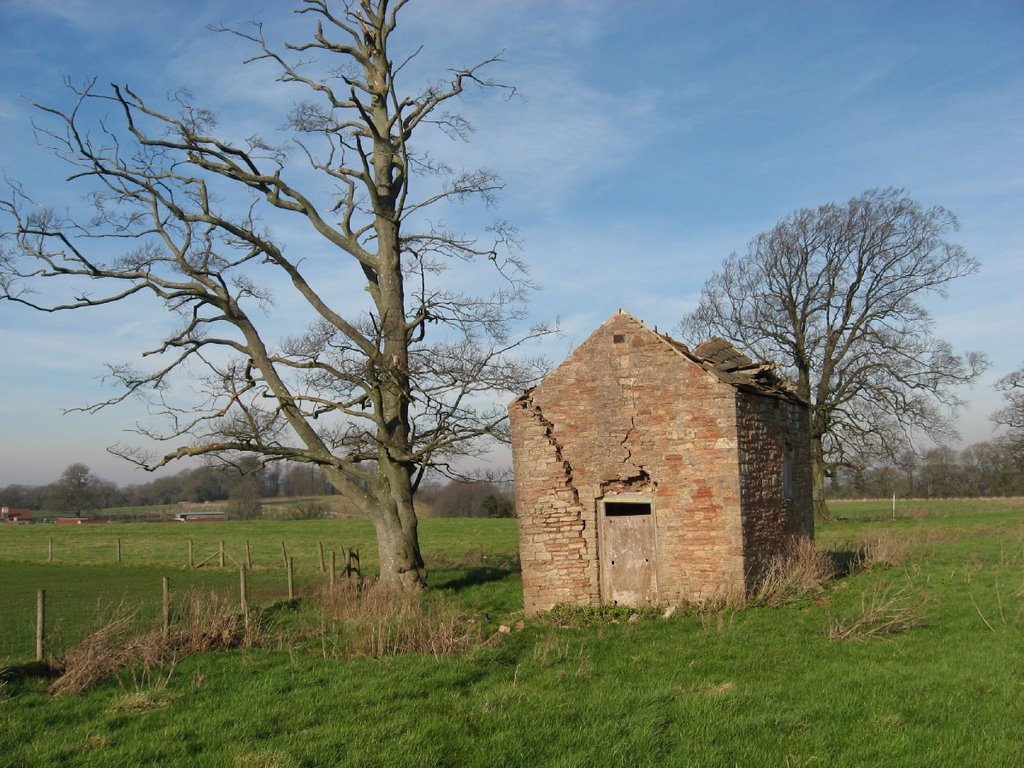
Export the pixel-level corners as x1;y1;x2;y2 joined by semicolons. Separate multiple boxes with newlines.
600;499;657;607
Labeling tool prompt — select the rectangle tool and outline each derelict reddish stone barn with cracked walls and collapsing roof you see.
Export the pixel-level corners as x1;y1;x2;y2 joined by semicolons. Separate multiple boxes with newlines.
509;310;814;613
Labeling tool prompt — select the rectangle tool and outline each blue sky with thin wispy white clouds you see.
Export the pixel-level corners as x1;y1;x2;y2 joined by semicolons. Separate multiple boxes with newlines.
0;0;1024;486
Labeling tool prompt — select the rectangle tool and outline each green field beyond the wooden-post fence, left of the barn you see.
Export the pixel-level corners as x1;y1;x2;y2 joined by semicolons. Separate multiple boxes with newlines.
0;519;517;664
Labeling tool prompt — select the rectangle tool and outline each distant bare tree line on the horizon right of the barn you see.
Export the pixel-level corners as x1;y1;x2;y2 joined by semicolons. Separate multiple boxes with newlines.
829;439;1024;499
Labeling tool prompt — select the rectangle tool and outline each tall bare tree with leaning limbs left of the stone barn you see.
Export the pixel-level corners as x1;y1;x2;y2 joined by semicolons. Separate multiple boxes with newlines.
0;0;548;589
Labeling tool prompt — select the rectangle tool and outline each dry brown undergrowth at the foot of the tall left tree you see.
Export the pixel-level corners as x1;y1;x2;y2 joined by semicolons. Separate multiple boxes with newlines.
321;583;479;657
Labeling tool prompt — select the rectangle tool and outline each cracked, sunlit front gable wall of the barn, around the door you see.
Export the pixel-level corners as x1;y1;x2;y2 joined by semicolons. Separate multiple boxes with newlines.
510;312;744;612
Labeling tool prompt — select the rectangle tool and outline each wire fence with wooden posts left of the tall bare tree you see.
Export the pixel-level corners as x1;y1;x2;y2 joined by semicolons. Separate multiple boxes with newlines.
0;540;362;666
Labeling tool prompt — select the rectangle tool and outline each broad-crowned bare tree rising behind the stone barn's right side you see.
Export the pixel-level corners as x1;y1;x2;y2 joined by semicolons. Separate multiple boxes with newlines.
681;188;986;519
